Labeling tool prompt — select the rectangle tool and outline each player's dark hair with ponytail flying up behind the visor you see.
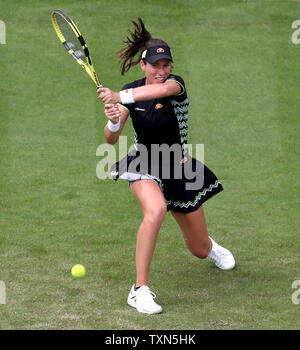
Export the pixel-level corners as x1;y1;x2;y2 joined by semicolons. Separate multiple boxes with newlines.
117;17;169;75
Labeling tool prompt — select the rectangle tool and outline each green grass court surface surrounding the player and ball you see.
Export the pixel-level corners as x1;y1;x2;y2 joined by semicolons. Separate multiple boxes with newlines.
0;0;300;330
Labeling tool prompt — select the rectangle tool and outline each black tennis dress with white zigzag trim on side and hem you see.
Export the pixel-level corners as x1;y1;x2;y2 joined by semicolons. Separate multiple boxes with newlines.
111;74;223;213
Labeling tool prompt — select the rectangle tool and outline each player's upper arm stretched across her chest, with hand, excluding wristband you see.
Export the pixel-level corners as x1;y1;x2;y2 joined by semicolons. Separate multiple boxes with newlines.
97;80;182;103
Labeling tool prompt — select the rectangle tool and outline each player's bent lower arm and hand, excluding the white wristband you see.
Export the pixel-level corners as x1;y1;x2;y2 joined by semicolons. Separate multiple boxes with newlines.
104;104;129;145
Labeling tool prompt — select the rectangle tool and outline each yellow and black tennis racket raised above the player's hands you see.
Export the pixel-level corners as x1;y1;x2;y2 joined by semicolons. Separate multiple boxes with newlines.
51;10;103;88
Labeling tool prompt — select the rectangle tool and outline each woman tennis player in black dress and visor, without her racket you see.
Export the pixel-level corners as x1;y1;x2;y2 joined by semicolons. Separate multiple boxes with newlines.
97;18;235;314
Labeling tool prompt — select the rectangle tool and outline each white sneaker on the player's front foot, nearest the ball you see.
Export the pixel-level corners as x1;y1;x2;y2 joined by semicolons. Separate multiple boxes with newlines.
127;285;162;314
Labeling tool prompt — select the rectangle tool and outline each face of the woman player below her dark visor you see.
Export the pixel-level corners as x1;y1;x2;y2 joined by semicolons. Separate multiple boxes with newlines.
141;59;172;84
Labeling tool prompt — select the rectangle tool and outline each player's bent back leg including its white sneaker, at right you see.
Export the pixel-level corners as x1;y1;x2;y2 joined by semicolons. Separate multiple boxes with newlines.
171;206;235;270
